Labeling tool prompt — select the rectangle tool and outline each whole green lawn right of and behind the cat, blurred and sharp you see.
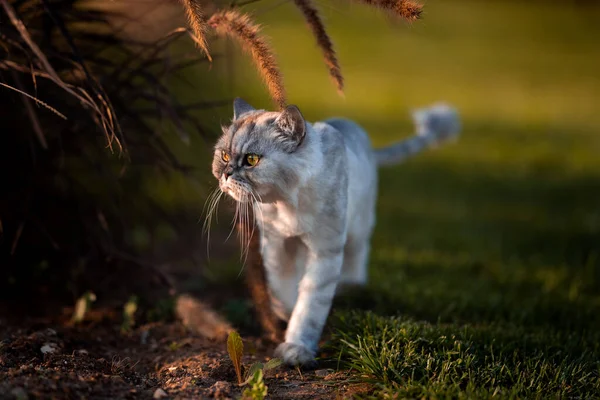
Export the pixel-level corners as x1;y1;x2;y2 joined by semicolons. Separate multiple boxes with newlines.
177;0;600;398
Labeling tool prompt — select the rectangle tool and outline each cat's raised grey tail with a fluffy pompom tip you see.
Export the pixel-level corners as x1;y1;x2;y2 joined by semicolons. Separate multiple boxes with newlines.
375;104;460;166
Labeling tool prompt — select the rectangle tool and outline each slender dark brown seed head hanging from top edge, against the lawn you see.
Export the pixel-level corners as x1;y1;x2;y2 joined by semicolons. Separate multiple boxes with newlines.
294;0;344;94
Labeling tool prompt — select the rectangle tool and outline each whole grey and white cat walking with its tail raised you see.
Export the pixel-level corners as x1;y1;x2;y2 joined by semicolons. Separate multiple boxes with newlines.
212;99;460;365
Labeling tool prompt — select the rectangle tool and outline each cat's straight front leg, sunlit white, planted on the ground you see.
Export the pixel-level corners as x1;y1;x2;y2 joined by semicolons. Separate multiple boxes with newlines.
275;240;344;365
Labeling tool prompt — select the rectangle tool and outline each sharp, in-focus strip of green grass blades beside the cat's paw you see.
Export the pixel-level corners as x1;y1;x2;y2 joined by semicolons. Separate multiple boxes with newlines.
333;313;600;398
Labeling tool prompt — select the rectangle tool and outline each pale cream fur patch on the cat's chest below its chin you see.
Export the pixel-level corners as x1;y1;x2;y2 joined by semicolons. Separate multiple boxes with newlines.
257;203;312;237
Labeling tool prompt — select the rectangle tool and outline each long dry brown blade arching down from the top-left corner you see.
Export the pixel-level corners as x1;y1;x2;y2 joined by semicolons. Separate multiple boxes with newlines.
0;0;123;150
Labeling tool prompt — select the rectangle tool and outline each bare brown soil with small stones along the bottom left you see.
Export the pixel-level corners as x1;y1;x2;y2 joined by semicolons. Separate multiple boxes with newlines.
0;310;368;399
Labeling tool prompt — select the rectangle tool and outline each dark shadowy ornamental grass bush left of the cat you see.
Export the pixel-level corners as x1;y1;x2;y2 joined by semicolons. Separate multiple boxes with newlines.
0;0;217;309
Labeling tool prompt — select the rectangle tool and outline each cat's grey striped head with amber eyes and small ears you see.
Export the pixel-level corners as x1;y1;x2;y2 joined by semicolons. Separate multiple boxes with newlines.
212;98;307;202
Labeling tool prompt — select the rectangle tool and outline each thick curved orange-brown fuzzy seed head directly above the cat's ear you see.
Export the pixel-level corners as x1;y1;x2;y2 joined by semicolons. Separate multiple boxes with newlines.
208;10;286;108
